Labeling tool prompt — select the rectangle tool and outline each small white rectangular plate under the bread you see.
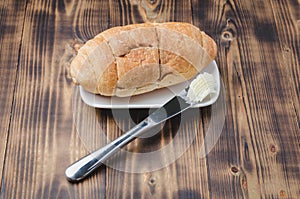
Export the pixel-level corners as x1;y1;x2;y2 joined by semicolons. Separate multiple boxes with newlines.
80;61;220;109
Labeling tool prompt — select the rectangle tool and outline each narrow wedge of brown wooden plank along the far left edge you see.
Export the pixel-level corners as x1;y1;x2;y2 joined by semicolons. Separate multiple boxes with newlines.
0;1;25;190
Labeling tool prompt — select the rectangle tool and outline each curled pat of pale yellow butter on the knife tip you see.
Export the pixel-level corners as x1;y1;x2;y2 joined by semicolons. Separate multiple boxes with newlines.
187;72;217;103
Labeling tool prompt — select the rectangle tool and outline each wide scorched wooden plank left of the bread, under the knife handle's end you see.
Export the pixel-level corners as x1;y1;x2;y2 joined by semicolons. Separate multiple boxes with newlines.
1;1;108;198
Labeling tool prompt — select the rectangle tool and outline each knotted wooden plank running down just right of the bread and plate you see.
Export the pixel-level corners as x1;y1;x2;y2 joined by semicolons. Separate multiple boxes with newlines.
192;1;247;198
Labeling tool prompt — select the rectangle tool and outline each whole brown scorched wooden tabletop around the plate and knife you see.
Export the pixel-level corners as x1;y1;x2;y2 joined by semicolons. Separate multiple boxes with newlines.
0;0;300;199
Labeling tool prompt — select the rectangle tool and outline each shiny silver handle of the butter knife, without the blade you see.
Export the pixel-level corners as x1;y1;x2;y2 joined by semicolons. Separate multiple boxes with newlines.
65;118;157;182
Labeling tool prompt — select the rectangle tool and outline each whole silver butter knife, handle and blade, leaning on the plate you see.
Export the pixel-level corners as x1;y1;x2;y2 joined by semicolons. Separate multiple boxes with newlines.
65;94;191;182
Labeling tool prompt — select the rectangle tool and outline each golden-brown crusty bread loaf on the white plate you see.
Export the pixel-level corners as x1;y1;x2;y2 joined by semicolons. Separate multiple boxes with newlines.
70;22;217;97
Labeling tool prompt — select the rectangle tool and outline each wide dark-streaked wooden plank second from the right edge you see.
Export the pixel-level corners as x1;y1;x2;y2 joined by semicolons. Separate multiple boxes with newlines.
233;2;299;198
